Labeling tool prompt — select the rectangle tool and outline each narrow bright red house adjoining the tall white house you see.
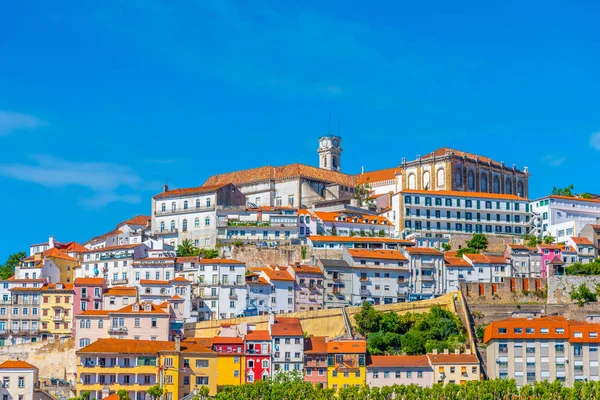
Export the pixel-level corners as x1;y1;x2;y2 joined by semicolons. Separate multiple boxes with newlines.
245;330;271;383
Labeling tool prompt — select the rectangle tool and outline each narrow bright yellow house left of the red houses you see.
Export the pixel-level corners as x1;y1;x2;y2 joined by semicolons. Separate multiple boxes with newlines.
212;336;246;390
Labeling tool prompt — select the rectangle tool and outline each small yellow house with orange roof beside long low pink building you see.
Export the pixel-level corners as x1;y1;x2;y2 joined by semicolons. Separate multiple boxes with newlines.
327;340;367;391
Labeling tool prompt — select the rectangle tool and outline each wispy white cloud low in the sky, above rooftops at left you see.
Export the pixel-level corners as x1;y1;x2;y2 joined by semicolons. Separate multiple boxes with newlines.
0;155;160;208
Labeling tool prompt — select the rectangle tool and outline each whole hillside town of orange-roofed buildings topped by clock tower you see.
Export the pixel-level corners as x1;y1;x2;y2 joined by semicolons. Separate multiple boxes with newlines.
0;135;600;400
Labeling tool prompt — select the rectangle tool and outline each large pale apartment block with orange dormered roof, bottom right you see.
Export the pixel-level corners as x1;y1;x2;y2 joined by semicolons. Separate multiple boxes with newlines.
484;316;600;386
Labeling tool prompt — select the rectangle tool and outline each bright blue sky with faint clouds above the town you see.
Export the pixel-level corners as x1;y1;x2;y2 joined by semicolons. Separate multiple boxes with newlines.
0;0;600;262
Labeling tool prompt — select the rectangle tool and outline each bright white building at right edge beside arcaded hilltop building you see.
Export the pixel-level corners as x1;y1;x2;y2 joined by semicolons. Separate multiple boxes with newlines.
531;195;600;243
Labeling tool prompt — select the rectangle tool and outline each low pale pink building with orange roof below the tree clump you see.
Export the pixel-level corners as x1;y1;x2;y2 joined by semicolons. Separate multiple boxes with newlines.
367;356;433;387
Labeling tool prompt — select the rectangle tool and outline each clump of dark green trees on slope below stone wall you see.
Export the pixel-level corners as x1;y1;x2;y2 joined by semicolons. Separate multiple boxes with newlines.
355;302;465;355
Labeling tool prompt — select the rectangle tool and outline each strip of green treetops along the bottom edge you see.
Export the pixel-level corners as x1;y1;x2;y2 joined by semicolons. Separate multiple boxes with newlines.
215;374;600;400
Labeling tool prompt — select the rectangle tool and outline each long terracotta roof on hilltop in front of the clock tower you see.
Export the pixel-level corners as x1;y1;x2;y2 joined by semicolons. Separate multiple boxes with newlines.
204;163;356;187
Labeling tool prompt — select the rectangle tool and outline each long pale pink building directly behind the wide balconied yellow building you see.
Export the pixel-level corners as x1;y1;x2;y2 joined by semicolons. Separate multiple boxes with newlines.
75;303;170;350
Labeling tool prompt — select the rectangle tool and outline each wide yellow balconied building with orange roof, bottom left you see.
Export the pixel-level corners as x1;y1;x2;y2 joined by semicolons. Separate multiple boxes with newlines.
76;339;179;400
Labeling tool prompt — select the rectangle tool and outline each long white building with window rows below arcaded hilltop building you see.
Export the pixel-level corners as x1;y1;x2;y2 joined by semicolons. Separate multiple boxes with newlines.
397;190;531;236
